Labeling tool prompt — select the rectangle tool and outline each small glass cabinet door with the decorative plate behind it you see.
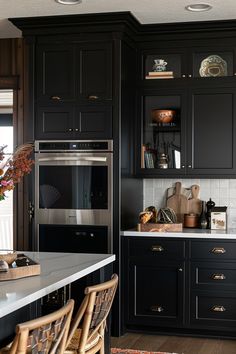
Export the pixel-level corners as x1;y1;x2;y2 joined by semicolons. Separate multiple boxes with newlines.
192;49;234;78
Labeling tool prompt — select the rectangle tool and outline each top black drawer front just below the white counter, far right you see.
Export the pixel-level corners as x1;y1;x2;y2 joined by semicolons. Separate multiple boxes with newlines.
191;241;236;262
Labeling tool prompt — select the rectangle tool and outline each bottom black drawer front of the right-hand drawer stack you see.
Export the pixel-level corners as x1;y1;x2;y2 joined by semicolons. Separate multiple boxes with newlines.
191;292;236;328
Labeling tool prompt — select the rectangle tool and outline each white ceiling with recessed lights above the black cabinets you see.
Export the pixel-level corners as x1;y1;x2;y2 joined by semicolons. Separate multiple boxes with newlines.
0;0;236;38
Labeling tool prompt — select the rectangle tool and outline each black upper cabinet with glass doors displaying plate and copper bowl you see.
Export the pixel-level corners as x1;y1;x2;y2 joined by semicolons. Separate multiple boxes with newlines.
135;38;236;178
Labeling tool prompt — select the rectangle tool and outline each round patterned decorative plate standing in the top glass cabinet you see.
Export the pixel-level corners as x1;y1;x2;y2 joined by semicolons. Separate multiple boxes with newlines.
199;55;227;77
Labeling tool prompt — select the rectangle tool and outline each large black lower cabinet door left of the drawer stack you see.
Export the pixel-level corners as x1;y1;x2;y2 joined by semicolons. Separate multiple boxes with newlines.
128;259;184;326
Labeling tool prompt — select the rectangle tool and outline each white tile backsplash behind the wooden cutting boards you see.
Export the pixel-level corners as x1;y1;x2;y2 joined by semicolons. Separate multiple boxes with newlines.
143;178;236;228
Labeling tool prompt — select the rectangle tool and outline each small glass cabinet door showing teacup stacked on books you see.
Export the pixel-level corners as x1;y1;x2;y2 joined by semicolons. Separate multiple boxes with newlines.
143;51;184;80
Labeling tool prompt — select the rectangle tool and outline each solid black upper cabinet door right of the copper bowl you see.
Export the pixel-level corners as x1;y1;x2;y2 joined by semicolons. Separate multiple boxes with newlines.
188;88;236;175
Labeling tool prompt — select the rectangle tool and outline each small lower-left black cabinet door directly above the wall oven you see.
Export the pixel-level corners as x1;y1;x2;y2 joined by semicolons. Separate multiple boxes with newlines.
35;105;74;139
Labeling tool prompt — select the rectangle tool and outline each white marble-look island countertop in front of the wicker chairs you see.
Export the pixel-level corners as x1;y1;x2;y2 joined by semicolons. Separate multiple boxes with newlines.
0;252;115;318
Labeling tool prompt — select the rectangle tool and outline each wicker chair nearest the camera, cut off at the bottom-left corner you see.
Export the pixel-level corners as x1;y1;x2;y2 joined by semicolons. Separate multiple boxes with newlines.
0;300;74;354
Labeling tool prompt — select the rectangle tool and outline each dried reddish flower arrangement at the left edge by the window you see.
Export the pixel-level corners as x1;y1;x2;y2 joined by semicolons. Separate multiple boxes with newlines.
0;143;34;201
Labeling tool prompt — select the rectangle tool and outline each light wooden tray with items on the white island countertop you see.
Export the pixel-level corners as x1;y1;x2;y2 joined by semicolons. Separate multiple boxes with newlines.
0;253;40;281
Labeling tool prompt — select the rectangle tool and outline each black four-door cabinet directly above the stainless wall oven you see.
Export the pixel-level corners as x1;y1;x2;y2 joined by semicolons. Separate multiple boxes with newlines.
35;39;113;139
